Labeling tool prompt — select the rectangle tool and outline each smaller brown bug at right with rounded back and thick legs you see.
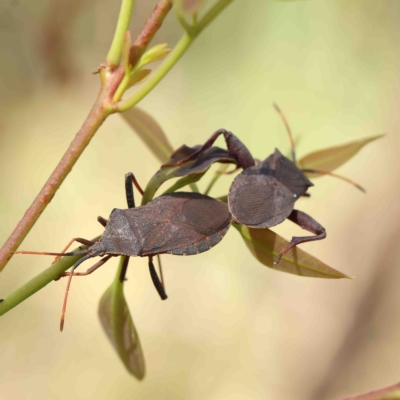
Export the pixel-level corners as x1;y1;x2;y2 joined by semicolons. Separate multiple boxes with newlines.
166;104;364;264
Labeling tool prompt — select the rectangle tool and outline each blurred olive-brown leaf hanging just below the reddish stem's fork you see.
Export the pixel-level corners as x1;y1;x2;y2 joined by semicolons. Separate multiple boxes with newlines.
121;107;173;163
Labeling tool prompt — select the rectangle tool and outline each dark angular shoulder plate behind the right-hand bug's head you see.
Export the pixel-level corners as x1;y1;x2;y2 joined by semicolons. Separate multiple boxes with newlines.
261;149;313;197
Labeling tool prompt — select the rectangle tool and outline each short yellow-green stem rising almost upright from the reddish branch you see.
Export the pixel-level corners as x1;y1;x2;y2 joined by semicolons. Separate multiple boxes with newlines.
106;0;135;67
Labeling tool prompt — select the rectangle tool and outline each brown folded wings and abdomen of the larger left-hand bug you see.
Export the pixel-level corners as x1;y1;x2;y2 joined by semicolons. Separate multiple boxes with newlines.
131;193;232;256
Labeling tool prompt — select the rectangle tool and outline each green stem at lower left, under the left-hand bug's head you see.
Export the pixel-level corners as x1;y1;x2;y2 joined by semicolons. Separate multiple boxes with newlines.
0;236;100;316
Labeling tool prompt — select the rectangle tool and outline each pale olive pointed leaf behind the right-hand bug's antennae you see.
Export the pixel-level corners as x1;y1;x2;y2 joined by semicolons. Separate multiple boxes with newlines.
297;135;384;178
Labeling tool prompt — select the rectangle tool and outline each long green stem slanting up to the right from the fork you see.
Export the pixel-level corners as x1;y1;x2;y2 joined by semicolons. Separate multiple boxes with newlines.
116;0;233;112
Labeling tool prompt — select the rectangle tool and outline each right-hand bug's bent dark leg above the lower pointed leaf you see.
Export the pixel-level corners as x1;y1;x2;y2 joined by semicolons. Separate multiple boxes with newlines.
274;210;326;265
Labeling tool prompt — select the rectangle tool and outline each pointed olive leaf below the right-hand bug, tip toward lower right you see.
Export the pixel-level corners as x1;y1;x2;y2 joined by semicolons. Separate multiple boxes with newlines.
233;224;350;279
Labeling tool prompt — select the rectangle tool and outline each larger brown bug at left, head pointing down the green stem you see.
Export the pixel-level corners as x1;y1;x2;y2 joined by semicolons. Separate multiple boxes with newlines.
17;173;232;330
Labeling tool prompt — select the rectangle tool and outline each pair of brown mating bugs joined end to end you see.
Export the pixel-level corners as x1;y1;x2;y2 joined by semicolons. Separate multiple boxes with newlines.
17;107;362;330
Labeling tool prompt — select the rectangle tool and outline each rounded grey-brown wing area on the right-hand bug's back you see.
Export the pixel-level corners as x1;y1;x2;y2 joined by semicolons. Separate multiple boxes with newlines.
228;164;297;228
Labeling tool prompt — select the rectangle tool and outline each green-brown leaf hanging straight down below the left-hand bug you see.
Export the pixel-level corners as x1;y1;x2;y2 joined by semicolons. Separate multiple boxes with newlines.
99;257;146;380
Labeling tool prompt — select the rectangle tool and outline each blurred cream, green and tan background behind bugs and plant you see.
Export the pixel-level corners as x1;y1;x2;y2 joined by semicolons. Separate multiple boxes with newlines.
0;0;400;400
